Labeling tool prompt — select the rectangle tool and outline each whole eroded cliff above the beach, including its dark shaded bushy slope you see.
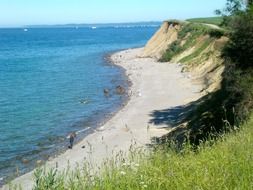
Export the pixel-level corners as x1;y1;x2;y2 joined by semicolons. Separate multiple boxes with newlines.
144;17;252;148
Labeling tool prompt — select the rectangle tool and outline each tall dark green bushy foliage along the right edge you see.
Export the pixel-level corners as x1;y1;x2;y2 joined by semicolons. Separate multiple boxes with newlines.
219;2;253;121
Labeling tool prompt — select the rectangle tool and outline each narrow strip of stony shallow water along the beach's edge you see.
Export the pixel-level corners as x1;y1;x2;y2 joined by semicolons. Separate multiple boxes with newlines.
0;49;131;187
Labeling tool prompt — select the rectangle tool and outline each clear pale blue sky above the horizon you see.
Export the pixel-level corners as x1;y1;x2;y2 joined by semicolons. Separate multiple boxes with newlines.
0;0;226;27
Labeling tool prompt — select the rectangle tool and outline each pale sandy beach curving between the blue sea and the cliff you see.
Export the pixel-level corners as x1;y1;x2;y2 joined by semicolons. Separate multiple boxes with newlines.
2;48;201;190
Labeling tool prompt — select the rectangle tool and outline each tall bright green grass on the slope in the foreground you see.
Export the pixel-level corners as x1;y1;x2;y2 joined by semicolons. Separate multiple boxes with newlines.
10;117;253;190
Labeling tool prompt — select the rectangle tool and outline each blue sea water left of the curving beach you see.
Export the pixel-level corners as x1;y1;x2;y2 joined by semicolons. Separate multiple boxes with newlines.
0;26;157;184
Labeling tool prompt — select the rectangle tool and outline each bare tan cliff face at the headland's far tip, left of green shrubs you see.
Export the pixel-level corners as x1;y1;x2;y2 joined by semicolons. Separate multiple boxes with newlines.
141;21;181;59
